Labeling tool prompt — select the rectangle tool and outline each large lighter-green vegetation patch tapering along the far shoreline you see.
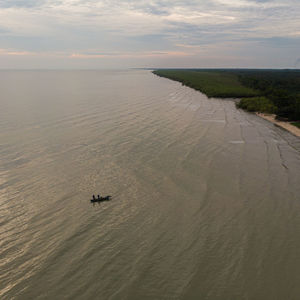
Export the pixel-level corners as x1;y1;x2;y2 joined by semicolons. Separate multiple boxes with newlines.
153;70;258;98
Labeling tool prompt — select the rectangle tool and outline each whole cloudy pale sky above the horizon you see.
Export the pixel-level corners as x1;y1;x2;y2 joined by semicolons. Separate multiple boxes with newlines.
0;0;300;69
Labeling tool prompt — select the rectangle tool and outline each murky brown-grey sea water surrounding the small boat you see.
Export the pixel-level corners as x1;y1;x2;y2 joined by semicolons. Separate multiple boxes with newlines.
0;70;300;300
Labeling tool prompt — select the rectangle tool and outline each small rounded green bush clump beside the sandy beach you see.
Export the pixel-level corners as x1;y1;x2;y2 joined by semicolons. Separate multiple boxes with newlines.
236;97;277;114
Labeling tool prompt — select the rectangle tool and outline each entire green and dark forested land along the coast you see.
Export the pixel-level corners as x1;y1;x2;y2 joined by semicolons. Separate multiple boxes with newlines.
153;69;300;122
